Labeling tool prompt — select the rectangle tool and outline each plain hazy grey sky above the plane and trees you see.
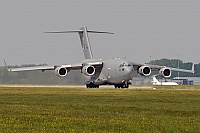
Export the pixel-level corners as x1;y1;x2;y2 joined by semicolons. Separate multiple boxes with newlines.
0;0;200;66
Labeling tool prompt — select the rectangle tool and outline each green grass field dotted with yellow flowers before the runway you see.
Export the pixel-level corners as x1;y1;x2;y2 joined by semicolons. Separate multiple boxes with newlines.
0;87;200;133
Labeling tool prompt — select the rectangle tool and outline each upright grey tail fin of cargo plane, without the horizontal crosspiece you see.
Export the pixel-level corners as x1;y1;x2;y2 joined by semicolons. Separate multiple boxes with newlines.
79;27;93;59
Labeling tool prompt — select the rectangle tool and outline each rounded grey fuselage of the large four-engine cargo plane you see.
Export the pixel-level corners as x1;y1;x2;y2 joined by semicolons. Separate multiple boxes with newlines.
83;59;134;88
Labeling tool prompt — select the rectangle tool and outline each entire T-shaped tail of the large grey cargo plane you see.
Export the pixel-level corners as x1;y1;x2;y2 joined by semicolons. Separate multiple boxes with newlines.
45;27;114;59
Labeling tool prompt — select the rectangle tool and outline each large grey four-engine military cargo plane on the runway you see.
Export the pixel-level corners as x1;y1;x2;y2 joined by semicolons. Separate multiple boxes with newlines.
8;27;194;88
